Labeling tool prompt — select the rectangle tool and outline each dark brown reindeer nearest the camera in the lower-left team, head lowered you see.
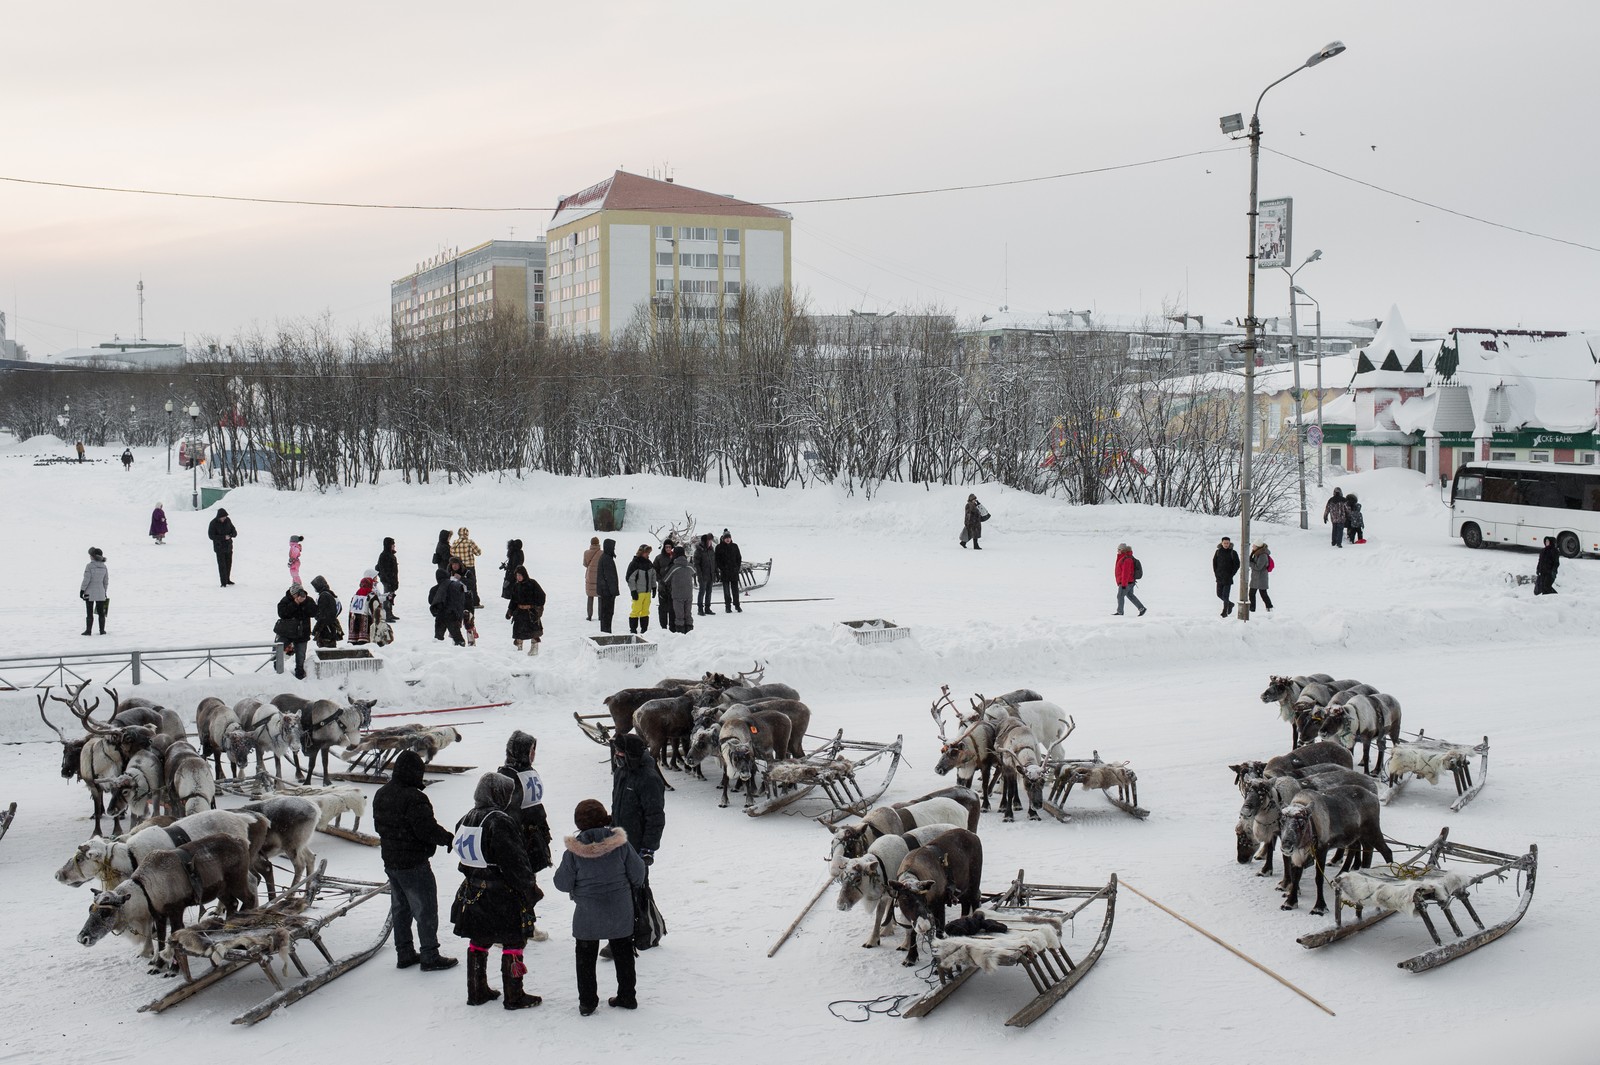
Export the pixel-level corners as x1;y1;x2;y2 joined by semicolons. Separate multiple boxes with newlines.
78;836;256;972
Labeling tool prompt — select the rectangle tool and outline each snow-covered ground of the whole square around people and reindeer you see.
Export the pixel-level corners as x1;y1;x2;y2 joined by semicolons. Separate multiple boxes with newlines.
0;441;1600;1062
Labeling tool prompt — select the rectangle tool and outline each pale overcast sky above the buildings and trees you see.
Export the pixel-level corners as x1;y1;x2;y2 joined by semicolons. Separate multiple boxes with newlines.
0;0;1600;357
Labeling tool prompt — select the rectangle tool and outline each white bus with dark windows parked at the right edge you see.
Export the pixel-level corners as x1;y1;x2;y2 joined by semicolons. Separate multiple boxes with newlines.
1450;462;1600;558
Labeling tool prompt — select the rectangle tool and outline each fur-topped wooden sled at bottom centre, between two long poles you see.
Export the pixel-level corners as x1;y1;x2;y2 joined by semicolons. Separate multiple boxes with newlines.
904;870;1117;1028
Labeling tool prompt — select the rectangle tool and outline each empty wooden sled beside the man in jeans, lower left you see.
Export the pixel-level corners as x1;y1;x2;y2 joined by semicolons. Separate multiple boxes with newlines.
139;862;392;1025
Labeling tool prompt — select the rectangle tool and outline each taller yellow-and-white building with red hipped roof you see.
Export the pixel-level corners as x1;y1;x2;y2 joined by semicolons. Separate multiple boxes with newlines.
547;170;790;339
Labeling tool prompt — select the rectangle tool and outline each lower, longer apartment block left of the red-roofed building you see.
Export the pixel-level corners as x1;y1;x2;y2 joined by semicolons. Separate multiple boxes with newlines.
389;240;546;339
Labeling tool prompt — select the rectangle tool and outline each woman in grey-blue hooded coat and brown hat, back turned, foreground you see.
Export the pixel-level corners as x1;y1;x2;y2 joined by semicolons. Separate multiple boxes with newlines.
555;800;645;1017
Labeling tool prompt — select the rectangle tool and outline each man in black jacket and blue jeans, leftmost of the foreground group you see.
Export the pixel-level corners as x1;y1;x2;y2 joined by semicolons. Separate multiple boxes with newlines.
373;750;456;972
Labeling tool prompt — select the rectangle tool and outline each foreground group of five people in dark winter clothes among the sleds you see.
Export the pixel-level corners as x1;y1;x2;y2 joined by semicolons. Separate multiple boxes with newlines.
373;729;666;1017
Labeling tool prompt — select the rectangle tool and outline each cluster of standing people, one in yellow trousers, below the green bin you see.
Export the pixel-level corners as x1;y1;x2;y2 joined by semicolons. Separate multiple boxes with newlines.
582;529;744;633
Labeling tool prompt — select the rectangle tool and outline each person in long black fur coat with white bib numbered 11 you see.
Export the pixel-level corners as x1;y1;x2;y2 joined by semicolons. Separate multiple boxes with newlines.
450;772;544;1009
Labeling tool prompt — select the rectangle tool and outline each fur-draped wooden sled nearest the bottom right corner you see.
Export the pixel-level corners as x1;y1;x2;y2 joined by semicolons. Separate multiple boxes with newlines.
1296;828;1539;972
